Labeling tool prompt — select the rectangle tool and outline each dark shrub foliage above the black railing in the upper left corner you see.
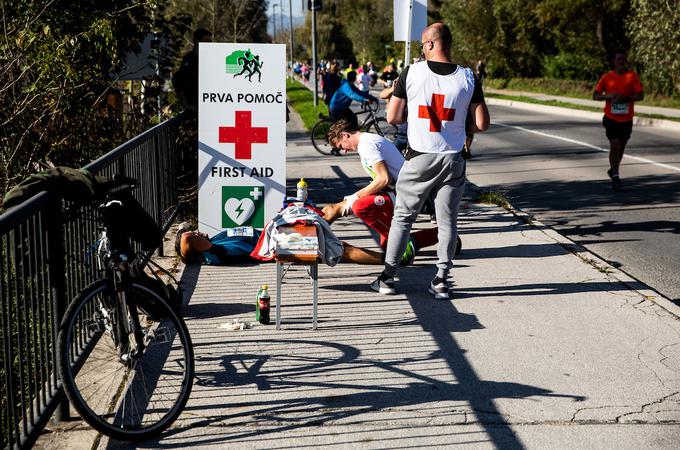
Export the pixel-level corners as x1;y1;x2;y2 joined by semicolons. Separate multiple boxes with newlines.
0;0;191;192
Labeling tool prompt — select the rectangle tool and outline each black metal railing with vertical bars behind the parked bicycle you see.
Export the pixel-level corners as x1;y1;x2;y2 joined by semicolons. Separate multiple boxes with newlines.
0;116;189;448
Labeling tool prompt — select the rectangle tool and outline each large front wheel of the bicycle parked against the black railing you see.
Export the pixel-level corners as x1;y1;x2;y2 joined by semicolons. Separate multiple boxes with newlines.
57;280;194;441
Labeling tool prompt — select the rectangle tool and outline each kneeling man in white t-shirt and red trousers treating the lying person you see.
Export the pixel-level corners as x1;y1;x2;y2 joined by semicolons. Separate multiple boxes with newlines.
323;119;437;265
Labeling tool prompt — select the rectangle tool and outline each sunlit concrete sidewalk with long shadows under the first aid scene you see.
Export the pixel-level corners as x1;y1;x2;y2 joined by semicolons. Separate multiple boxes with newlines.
94;110;680;449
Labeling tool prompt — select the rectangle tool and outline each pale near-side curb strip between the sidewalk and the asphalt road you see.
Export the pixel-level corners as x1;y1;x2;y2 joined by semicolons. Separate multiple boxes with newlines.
467;180;680;319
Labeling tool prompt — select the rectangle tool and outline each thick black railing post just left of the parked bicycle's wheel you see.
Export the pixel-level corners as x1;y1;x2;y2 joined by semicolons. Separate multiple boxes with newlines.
46;198;71;421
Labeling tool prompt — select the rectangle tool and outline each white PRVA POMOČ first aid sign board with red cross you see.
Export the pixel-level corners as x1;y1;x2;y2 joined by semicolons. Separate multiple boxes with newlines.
198;43;286;235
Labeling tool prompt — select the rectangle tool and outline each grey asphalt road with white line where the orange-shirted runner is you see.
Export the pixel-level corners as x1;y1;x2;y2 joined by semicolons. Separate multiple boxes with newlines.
467;106;680;304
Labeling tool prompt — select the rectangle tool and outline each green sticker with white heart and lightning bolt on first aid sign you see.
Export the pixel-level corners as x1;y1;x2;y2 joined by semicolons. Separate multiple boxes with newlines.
222;186;264;228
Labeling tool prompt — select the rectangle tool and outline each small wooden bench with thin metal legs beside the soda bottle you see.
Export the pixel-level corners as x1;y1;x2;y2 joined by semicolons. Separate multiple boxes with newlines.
274;224;320;330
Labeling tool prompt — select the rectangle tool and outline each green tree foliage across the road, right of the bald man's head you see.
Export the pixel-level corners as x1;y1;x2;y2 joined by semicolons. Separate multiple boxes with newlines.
439;0;680;95
